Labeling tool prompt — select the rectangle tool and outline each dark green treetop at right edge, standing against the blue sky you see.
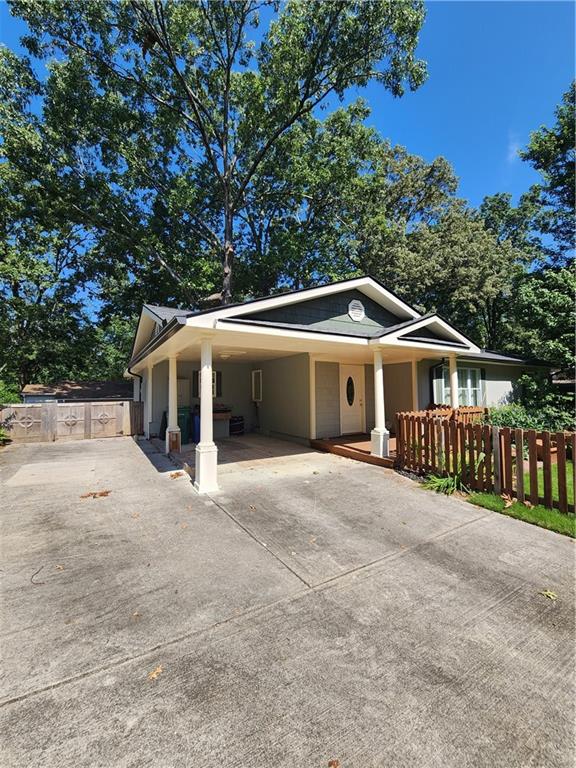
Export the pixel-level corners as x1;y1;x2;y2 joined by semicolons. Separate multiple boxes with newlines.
520;81;576;264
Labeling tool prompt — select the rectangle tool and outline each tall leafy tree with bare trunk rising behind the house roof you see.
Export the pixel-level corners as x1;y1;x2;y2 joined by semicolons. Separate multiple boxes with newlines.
11;0;425;303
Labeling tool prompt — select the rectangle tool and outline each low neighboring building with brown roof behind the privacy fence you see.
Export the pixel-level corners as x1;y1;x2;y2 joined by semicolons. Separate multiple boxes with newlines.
20;380;137;404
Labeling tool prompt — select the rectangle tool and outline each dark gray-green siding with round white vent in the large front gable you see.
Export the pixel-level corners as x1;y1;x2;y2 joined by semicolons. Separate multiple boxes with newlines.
243;290;406;337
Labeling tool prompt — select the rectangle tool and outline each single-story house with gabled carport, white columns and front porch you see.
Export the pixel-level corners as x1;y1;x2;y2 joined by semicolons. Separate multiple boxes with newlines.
128;277;548;492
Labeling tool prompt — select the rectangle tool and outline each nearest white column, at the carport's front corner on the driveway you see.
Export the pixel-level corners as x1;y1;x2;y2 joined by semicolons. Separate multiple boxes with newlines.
194;339;218;493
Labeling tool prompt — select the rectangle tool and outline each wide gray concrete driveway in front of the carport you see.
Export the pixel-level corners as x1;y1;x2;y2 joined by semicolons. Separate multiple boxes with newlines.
0;438;575;768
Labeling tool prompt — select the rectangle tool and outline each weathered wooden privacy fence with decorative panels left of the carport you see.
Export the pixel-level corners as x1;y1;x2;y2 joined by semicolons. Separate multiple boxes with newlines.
0;400;144;443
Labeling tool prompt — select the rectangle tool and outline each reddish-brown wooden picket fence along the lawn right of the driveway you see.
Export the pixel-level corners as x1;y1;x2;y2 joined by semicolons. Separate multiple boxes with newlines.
396;413;576;513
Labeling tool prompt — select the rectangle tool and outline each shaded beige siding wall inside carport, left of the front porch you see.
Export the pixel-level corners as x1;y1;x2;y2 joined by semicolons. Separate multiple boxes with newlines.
253;354;310;441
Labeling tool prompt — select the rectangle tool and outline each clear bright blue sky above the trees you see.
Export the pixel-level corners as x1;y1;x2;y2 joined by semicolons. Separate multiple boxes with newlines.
0;0;575;205
